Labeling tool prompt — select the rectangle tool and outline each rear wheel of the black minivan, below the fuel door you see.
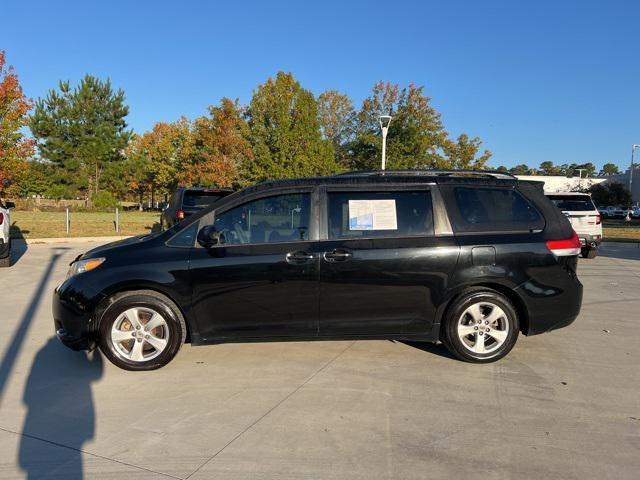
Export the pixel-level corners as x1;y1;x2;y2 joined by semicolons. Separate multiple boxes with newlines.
442;289;520;363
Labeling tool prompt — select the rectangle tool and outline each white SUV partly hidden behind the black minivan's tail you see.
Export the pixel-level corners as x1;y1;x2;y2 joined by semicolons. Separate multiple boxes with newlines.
545;192;602;258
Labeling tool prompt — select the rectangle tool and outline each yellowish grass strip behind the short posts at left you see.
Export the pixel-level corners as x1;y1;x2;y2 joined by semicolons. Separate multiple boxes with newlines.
11;210;160;238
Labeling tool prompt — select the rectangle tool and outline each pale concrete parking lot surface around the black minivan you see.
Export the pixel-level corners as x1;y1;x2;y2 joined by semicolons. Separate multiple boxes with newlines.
0;244;640;480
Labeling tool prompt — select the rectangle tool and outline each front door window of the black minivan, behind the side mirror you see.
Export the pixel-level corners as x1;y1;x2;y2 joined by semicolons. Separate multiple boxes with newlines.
214;193;311;245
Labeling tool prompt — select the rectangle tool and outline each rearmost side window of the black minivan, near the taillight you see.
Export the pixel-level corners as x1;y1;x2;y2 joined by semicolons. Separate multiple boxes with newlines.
453;187;544;232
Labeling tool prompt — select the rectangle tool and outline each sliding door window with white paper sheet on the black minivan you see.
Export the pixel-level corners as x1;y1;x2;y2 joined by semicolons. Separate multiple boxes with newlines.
328;191;433;240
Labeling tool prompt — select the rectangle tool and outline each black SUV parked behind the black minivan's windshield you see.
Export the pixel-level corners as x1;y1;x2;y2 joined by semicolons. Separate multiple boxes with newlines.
160;187;233;228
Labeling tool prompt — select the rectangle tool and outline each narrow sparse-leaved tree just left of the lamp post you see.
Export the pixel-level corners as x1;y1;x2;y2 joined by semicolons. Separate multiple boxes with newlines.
318;90;356;167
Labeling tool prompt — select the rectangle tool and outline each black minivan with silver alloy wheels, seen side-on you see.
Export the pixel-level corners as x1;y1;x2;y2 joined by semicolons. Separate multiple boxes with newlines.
53;171;582;370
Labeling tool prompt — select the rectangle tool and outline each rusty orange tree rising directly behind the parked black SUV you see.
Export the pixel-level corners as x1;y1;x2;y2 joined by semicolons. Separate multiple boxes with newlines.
188;98;253;187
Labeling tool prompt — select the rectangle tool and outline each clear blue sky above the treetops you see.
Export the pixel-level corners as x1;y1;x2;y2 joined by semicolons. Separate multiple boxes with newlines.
0;0;640;168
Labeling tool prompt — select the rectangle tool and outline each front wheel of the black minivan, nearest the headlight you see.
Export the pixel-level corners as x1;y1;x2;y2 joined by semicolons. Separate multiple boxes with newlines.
99;290;187;371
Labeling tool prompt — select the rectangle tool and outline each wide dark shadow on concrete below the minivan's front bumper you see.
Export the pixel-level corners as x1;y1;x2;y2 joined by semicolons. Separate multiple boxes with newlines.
18;337;103;480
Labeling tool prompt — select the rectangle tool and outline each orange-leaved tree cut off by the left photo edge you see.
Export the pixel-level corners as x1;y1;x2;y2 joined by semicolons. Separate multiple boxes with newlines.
0;51;33;193
